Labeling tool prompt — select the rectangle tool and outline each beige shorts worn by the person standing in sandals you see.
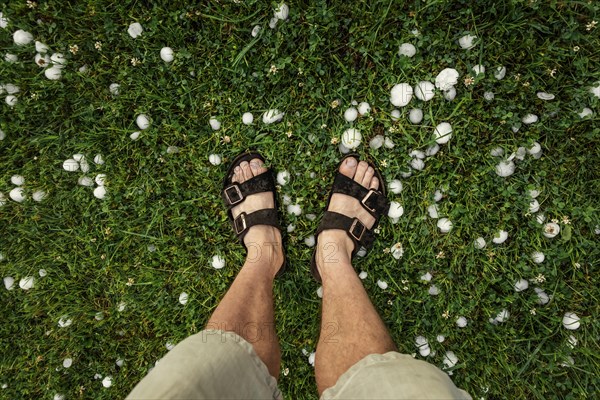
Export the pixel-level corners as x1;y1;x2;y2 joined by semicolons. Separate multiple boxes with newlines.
127;330;471;399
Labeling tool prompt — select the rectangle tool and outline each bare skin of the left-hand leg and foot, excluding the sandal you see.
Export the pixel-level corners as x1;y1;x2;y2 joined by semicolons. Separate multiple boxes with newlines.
207;159;283;378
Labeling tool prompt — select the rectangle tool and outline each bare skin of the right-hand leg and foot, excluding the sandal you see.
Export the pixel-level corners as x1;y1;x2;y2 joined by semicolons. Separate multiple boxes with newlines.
315;158;397;395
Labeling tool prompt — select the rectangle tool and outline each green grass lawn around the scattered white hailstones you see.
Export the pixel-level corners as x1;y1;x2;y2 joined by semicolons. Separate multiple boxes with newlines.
0;1;600;399
